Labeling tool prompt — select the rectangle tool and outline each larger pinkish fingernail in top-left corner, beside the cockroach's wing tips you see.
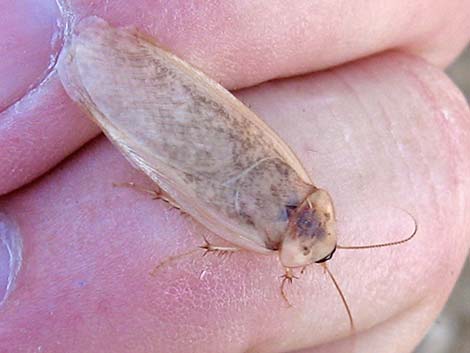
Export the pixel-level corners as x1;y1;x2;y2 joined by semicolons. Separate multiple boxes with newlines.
0;0;60;111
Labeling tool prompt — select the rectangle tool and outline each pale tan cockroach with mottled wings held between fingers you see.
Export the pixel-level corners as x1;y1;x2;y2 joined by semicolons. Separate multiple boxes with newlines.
58;17;416;327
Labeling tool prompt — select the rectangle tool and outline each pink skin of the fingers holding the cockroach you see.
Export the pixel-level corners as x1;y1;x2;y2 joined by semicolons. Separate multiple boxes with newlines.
0;1;470;353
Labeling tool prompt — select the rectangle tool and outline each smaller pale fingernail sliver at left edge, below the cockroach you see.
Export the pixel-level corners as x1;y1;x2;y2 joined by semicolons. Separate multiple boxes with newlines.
0;213;23;305
